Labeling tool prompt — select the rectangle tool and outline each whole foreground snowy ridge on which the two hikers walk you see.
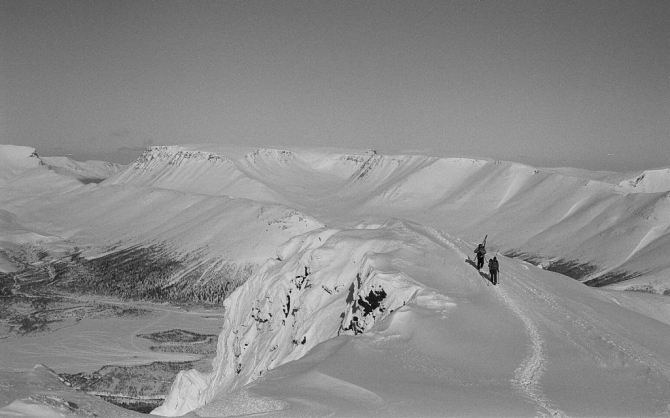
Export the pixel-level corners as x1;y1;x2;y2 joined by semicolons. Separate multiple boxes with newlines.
154;221;670;416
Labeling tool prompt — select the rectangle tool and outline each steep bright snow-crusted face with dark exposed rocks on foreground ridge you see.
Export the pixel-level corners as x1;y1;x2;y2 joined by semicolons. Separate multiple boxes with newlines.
156;222;430;416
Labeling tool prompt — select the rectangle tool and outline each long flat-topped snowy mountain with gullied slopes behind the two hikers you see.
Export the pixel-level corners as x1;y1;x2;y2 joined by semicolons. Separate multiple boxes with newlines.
106;146;670;292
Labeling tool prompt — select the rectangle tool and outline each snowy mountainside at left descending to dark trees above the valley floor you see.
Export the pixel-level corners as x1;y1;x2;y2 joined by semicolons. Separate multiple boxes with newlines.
0;146;323;302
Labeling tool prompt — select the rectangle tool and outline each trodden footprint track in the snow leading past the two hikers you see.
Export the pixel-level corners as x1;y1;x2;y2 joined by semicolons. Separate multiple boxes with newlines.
429;228;566;417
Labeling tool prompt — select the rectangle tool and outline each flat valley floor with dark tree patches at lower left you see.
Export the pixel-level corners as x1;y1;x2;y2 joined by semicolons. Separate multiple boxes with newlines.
0;289;223;416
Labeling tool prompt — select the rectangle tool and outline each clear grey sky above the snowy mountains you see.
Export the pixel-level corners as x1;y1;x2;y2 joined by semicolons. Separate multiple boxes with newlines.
0;0;670;170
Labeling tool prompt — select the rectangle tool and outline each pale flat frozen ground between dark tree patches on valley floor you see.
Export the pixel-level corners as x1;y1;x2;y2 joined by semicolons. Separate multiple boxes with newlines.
0;298;223;417
